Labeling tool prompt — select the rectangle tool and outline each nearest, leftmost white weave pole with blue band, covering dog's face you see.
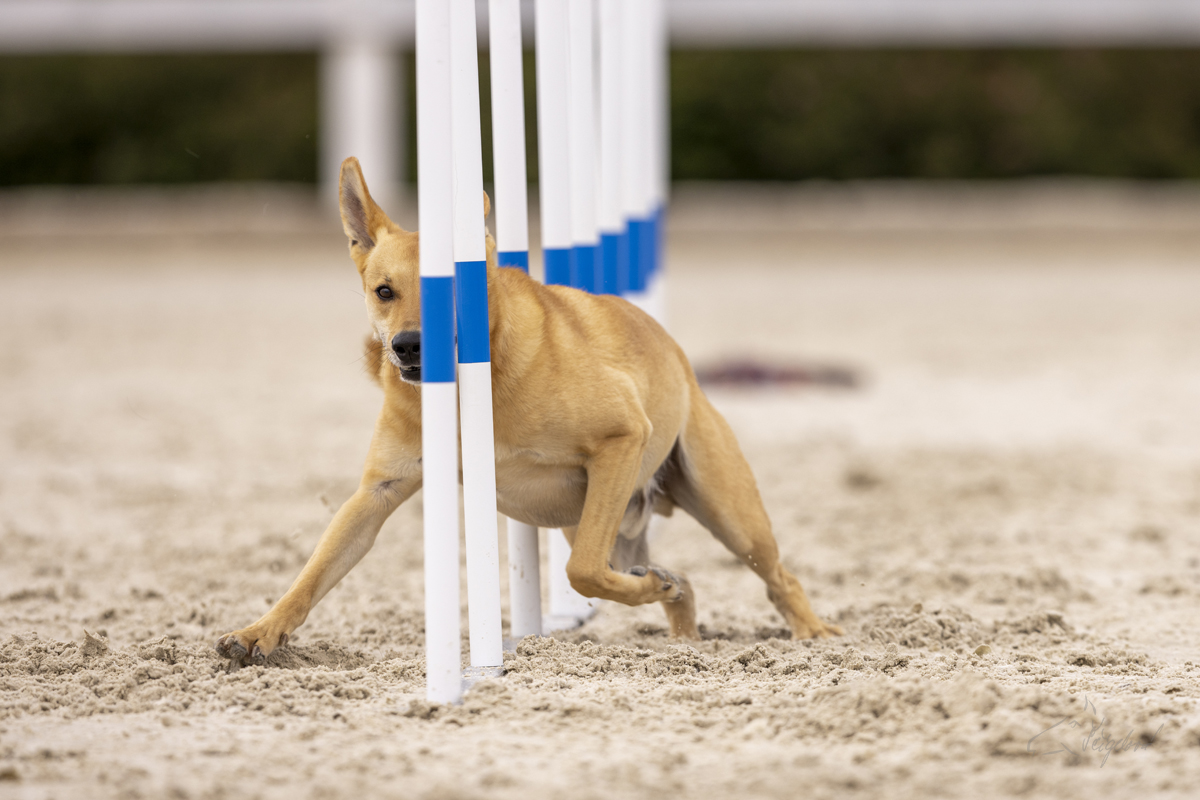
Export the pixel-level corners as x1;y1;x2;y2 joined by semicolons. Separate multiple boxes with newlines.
416;0;462;703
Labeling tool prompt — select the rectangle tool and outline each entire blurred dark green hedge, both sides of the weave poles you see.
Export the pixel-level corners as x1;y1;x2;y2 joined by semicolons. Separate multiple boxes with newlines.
0;49;1200;186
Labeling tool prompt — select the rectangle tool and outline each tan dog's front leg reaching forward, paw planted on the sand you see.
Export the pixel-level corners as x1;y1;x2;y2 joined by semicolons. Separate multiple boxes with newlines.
210;477;408;664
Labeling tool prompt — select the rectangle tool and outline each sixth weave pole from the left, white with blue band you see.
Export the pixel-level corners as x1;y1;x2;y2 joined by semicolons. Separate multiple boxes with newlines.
596;0;629;295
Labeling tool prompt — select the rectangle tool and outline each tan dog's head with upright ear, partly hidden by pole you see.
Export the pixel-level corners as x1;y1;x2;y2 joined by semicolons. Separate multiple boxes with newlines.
337;157;421;384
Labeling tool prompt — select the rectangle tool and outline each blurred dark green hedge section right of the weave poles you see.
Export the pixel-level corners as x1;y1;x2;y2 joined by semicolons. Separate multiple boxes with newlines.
672;50;1200;180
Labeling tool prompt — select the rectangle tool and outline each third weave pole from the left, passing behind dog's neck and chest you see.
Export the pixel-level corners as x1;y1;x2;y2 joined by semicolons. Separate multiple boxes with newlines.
488;0;541;642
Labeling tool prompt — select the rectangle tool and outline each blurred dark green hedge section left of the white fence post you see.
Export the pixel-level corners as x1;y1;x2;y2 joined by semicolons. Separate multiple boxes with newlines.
0;54;317;186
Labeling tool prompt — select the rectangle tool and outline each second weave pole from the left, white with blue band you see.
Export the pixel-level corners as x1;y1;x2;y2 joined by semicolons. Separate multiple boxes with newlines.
451;0;504;676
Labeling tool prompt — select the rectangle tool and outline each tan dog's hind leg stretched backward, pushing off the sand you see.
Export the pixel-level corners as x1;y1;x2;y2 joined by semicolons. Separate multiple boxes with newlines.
662;389;841;639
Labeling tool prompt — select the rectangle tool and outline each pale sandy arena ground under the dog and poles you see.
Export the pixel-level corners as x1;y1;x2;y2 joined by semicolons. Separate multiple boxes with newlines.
0;186;1200;800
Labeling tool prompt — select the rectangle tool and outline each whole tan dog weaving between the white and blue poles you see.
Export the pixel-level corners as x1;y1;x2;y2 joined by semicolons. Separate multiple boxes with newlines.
217;158;841;663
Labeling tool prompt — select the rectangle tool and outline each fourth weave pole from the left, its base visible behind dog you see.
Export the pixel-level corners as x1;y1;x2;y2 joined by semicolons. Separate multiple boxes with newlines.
534;0;595;631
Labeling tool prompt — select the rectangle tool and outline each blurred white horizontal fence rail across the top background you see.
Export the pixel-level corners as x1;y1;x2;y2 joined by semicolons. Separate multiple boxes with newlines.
7;0;1200;53
